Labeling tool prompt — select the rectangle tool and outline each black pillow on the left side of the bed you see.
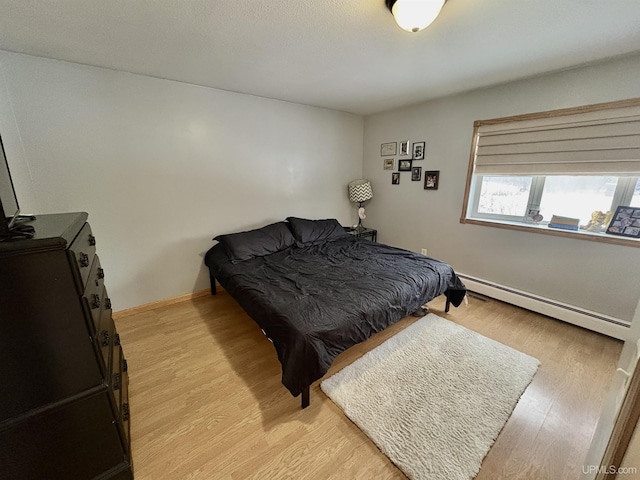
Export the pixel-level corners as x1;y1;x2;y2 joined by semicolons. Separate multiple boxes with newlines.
214;222;296;263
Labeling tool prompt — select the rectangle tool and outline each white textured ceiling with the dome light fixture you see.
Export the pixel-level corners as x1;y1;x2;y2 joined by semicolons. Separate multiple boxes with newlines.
0;0;640;114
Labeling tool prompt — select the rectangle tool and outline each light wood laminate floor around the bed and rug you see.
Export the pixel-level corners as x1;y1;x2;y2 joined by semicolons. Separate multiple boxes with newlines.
116;292;622;480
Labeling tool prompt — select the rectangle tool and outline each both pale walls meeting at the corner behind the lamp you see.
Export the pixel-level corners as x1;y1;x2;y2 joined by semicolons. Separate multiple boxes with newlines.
0;51;640;320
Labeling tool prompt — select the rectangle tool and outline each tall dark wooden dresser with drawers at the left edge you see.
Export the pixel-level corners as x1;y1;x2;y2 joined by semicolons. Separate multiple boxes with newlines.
0;213;133;480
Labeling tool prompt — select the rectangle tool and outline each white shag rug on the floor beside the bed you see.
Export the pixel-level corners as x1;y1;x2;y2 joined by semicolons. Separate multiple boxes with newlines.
320;313;540;480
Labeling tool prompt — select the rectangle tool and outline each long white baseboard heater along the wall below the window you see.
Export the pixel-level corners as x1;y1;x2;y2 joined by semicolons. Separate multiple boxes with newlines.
458;273;631;340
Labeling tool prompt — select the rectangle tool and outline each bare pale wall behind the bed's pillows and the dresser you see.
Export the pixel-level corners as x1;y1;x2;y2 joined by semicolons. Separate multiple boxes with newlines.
0;51;363;310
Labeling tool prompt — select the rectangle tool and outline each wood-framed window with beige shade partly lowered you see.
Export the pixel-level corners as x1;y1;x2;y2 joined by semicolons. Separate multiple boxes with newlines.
461;99;640;243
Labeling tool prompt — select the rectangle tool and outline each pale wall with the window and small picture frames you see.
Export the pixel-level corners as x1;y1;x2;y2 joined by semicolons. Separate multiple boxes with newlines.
364;52;640;321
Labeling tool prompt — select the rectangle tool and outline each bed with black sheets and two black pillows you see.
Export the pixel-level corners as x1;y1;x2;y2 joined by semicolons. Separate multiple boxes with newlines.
205;217;466;408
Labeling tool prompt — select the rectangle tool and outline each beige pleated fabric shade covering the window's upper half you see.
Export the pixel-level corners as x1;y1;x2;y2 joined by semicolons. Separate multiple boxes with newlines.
475;99;640;175
